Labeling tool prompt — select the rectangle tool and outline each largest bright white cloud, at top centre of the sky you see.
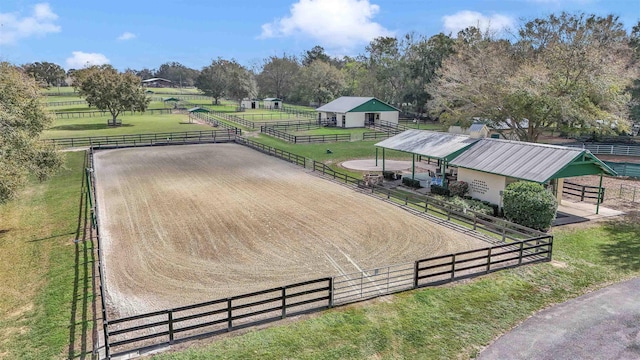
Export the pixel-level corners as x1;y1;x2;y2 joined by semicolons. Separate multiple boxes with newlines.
258;0;392;49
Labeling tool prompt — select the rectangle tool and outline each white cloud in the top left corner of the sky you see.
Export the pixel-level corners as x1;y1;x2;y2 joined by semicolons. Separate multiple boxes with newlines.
0;3;60;44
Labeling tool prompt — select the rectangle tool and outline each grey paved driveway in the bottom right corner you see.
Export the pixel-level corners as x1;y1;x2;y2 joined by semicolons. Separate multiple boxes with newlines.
478;278;640;360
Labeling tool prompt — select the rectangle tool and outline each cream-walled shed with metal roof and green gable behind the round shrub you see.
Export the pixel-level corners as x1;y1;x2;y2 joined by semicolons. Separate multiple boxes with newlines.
450;139;617;212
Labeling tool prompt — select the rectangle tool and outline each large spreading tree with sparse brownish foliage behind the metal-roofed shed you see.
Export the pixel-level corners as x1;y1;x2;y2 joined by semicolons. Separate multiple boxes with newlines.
429;13;637;142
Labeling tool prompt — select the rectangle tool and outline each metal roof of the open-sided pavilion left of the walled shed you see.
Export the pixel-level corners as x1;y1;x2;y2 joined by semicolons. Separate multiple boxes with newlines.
375;130;478;161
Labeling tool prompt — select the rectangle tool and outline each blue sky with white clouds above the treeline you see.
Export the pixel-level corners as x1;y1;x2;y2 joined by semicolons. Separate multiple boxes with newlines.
0;0;640;70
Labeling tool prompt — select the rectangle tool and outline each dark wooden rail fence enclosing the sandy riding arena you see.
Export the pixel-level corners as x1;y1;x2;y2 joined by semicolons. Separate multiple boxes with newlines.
87;140;553;358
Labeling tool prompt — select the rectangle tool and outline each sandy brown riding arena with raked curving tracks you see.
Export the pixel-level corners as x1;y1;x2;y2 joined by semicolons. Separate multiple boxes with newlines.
94;144;487;316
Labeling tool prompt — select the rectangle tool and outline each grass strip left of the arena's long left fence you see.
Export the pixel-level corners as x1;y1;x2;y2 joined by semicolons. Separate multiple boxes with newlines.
0;152;93;359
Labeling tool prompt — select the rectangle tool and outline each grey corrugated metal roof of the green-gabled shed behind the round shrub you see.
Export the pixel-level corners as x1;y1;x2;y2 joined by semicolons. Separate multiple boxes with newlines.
450;139;583;183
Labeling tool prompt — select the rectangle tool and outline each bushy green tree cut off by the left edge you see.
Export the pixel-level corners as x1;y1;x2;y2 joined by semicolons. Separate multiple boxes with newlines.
0;62;62;203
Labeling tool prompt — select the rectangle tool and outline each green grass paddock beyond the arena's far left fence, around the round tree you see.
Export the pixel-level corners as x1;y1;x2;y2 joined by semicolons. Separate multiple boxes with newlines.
43;114;214;139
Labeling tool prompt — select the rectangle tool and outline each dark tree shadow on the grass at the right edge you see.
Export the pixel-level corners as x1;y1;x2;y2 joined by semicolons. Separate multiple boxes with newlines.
598;211;640;271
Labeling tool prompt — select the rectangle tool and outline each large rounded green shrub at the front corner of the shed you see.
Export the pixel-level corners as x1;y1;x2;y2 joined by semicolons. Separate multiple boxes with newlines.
502;181;558;231
